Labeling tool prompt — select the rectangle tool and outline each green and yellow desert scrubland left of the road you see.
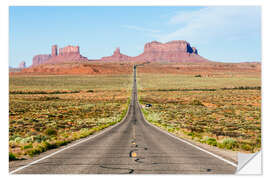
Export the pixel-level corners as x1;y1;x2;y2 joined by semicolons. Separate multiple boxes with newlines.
9;75;132;160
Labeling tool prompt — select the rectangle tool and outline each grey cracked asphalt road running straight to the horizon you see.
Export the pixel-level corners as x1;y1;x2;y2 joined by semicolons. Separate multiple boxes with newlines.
11;67;236;174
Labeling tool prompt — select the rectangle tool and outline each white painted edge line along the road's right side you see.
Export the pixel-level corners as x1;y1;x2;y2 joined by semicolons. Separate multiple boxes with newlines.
137;102;238;167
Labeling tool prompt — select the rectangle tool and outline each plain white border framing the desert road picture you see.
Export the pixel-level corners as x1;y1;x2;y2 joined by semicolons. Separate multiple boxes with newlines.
0;0;270;180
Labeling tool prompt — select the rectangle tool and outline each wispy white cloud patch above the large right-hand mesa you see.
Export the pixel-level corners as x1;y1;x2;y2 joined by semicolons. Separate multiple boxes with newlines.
157;6;261;43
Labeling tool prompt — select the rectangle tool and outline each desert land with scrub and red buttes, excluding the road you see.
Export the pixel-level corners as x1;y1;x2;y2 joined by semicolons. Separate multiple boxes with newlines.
9;40;261;164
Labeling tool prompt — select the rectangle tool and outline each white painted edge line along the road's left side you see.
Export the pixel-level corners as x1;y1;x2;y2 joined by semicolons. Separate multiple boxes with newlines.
9;98;131;174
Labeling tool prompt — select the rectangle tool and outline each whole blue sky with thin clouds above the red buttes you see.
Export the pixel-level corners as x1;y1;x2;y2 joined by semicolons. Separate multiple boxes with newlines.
9;6;261;67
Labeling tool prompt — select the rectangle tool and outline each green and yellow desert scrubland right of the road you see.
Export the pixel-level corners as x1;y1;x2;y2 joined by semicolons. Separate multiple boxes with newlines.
138;74;261;153
